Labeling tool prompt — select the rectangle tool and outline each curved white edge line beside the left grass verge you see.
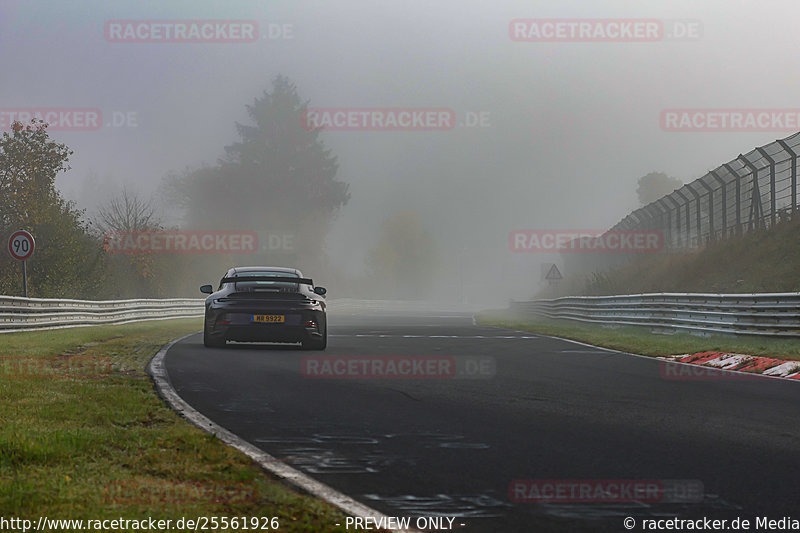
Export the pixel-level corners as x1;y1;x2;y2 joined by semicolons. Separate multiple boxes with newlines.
146;332;416;533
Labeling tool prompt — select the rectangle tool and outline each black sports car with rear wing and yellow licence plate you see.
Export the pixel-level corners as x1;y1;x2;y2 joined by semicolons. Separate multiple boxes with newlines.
200;267;328;350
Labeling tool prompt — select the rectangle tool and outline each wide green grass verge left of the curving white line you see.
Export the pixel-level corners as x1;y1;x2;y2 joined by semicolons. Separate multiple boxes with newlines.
0;320;378;532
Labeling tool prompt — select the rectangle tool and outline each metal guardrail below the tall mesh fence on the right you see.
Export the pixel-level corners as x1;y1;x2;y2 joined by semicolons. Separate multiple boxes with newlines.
510;292;800;337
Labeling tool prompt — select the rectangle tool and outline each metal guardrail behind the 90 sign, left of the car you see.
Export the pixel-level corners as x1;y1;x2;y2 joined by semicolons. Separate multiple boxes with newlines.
0;296;204;333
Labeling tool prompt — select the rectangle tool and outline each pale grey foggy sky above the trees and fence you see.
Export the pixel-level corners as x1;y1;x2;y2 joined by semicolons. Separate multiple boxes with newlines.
0;0;800;303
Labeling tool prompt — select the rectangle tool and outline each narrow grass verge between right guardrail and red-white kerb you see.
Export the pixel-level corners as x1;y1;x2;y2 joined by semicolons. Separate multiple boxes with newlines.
477;310;800;360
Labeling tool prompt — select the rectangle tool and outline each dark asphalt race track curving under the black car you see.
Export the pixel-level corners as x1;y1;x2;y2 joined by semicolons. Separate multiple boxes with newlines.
166;313;800;532
